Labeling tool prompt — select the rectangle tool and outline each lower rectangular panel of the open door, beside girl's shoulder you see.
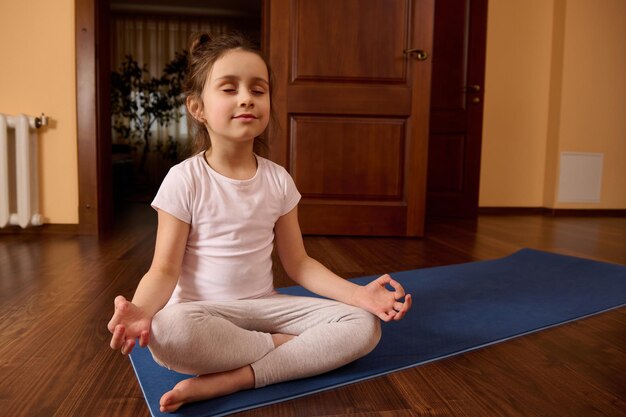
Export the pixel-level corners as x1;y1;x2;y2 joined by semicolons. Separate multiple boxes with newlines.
290;116;405;200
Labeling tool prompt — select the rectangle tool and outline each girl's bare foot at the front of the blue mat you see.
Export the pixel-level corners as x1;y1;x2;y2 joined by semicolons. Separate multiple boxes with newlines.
159;365;254;413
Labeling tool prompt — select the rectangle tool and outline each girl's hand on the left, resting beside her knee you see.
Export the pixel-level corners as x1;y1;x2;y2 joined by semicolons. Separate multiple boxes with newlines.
107;295;152;355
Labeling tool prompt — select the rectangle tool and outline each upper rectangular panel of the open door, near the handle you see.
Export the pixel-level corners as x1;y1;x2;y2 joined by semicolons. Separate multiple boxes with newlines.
291;0;409;82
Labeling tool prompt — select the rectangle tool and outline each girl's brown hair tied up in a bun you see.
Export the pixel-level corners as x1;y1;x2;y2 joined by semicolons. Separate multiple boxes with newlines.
183;33;275;156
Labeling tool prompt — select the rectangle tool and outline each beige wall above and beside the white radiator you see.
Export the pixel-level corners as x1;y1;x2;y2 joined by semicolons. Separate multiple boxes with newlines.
0;0;78;223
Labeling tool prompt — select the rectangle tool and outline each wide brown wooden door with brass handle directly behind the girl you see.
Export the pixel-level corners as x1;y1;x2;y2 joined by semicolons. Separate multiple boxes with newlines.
266;0;434;236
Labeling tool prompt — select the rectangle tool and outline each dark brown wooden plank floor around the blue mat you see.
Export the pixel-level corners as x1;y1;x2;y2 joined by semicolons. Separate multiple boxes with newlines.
0;209;626;417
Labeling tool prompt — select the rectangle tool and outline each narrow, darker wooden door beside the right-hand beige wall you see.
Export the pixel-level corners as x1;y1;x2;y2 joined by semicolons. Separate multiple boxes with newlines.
426;0;487;218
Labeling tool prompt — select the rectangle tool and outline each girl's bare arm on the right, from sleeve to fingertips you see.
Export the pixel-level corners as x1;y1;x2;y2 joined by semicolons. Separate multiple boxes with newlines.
274;207;411;321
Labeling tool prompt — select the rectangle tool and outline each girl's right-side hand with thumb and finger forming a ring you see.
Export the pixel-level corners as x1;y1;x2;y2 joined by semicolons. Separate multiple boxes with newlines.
352;274;412;321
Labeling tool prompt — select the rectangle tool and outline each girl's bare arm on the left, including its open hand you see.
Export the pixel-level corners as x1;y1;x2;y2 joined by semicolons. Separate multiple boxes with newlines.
107;210;189;354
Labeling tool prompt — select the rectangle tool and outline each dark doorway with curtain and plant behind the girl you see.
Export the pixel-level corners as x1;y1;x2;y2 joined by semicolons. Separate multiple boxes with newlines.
106;0;262;224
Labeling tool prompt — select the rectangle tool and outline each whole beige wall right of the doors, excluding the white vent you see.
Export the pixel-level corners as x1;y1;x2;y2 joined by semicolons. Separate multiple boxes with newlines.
479;0;626;209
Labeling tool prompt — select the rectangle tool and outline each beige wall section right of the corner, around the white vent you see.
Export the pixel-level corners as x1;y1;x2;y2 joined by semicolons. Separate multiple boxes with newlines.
555;0;626;208
